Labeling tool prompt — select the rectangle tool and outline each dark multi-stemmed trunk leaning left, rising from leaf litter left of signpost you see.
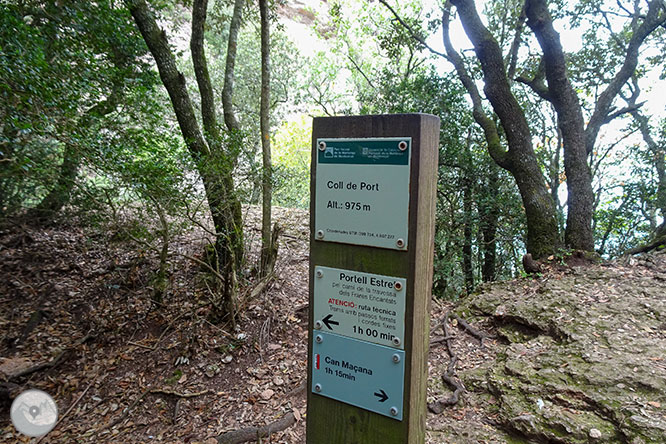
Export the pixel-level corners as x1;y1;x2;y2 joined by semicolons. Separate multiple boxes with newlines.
126;0;244;323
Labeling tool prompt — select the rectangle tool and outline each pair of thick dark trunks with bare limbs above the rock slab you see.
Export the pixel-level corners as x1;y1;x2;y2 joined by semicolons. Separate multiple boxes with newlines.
380;0;666;259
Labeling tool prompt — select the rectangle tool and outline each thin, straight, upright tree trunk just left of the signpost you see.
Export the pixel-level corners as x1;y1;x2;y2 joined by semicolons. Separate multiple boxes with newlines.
259;0;277;277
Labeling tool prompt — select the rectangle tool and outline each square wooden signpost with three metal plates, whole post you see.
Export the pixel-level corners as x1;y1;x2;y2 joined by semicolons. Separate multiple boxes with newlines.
307;114;439;444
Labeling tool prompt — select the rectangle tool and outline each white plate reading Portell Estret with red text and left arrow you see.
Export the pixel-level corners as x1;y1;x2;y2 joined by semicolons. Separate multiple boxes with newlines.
313;266;407;349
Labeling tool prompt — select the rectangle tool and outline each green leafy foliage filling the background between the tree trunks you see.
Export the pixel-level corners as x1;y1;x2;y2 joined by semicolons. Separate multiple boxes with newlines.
0;0;666;306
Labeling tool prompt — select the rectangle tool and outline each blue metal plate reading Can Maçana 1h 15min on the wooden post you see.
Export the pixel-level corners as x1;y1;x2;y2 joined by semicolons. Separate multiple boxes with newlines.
312;332;405;421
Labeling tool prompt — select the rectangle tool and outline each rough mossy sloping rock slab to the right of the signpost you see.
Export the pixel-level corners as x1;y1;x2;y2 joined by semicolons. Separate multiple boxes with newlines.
429;252;666;444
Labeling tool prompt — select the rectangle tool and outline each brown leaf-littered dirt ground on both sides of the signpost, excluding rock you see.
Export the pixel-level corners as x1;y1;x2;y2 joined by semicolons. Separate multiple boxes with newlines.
0;209;506;444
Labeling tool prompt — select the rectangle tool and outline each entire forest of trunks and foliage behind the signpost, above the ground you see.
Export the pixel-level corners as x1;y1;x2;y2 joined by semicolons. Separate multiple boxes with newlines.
0;0;666;302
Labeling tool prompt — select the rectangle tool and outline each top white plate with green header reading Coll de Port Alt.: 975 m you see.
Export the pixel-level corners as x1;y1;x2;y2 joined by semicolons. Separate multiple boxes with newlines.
314;137;412;250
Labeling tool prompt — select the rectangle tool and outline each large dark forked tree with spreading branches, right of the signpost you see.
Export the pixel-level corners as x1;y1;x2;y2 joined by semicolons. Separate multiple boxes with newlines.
380;0;666;258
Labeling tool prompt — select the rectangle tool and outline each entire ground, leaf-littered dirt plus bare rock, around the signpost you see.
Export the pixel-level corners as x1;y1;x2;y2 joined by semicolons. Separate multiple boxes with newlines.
0;210;666;444
